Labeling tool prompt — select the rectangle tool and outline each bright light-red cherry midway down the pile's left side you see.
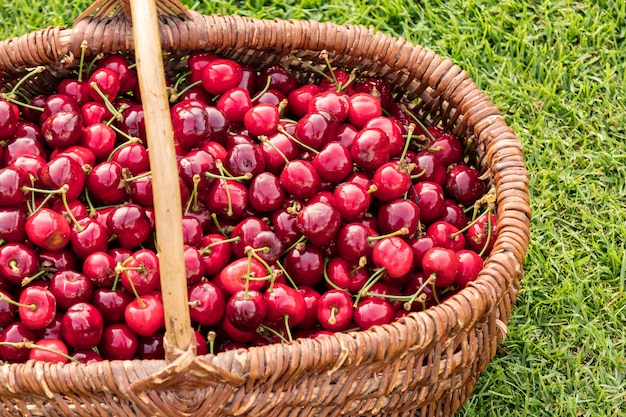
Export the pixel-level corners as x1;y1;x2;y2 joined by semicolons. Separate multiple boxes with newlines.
25;208;71;251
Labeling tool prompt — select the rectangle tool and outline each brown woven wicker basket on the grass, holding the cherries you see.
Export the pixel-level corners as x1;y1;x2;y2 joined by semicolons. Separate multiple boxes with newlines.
0;0;530;417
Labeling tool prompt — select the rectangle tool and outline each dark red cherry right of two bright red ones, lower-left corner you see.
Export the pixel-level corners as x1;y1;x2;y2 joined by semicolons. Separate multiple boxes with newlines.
61;303;104;349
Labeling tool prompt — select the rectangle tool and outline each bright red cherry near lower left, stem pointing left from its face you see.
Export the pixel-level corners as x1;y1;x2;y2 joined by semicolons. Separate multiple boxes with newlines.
17;285;57;330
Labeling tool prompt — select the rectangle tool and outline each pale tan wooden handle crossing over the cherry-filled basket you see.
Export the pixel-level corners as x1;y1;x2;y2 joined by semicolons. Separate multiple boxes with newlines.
129;0;195;362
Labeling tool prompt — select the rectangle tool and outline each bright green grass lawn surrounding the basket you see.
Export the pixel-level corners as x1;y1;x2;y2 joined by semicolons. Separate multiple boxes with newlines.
0;0;626;417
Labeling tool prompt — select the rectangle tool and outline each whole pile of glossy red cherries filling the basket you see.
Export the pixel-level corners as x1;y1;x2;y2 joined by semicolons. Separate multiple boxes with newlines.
0;52;497;362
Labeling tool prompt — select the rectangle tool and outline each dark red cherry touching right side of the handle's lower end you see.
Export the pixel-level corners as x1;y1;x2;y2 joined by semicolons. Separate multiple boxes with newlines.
189;281;226;326
